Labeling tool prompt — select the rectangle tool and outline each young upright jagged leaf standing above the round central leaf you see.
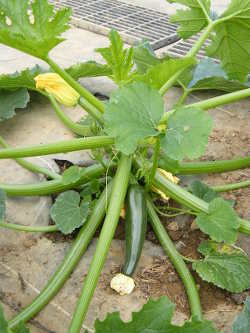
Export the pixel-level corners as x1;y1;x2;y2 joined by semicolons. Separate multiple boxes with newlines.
96;29;133;84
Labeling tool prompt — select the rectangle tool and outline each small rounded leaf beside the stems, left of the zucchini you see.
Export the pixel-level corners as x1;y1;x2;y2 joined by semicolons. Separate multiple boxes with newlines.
50;191;89;235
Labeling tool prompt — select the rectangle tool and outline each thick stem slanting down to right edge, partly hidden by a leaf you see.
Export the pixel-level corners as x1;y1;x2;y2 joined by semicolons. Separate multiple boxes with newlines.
153;171;250;234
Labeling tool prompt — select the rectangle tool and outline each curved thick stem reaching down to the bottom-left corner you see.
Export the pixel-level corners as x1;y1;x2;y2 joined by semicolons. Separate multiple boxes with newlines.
9;184;111;329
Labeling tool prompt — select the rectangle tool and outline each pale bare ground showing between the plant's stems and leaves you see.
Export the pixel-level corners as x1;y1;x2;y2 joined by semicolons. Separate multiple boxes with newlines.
0;0;250;333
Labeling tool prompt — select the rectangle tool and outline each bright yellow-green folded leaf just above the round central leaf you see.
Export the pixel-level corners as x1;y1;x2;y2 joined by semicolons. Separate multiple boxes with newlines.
133;58;194;89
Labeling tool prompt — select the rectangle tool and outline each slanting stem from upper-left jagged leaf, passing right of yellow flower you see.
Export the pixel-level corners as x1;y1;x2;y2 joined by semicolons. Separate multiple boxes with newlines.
46;57;104;113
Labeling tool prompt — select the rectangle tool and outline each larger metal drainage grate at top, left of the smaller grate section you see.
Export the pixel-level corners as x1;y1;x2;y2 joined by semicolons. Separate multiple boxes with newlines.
51;0;179;50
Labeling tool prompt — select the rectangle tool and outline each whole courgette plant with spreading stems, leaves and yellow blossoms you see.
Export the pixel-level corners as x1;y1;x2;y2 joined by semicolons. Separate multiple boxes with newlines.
0;0;250;333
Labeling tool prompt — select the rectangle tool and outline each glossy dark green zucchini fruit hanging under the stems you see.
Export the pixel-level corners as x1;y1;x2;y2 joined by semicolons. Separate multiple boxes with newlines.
122;185;147;276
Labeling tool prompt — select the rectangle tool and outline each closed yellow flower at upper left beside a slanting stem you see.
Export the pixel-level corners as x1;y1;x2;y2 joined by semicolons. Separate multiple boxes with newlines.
35;73;80;106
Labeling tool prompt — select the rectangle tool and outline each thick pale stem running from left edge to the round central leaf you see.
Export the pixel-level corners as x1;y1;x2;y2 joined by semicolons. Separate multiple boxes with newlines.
0;136;114;159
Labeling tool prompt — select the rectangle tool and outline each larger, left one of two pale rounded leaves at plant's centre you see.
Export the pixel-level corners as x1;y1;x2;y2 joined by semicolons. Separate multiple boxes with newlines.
104;82;163;155
